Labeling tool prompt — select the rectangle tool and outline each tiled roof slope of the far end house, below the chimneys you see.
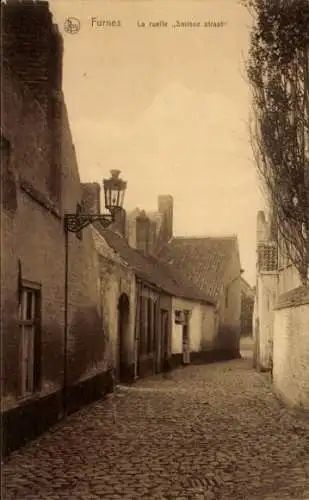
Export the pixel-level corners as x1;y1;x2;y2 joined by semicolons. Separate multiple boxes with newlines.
158;236;238;301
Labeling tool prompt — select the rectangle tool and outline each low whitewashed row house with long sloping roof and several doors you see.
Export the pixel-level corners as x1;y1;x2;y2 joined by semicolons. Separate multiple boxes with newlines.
94;205;215;382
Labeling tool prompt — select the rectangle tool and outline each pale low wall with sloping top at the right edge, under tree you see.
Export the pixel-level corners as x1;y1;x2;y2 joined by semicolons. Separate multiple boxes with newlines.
273;288;309;410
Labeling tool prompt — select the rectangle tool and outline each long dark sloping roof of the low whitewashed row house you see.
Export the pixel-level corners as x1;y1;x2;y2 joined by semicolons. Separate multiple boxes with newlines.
95;224;214;305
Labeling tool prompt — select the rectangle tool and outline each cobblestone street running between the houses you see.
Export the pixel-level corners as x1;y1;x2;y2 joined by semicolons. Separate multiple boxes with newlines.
3;344;309;500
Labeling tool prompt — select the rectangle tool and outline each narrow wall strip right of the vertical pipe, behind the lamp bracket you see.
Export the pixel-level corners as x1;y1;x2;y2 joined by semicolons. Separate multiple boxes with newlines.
61;102;105;383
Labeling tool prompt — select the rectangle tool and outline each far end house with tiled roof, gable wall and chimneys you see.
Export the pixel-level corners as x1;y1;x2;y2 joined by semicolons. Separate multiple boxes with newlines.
126;195;243;360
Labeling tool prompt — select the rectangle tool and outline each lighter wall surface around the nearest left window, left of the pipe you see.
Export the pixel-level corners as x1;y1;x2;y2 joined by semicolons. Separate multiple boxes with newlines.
1;65;64;404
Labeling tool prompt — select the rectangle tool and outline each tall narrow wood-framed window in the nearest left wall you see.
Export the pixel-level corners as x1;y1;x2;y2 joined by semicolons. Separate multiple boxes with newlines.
19;285;40;397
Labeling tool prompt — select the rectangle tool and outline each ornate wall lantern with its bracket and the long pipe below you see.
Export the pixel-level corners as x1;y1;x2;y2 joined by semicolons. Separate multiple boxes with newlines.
62;170;127;416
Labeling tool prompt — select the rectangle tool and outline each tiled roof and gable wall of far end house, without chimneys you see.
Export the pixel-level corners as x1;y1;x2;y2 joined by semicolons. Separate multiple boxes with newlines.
157;236;243;359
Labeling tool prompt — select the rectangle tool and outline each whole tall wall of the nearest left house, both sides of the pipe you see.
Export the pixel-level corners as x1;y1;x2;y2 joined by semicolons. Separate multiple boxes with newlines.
1;2;104;408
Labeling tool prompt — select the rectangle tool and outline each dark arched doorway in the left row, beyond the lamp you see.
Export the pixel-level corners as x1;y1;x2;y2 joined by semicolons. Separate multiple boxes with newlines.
116;293;130;382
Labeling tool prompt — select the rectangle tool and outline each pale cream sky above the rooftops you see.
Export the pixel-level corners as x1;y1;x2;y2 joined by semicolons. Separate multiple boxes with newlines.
50;0;262;284
